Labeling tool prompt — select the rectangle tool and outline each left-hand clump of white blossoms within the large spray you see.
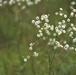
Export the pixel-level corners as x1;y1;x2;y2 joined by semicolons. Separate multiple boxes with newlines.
32;14;54;39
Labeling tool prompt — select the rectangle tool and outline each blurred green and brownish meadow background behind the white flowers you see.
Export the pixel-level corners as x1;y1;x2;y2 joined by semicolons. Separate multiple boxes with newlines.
0;0;76;75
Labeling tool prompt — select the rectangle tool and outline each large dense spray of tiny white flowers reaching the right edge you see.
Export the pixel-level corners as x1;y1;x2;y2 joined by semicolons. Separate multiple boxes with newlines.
32;3;76;51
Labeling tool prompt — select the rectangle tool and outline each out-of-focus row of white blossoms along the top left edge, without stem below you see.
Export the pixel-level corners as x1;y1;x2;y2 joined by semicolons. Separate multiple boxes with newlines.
0;0;41;9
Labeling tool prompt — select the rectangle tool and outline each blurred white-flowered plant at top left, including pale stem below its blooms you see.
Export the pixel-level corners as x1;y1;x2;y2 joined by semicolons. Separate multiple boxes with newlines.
0;0;42;22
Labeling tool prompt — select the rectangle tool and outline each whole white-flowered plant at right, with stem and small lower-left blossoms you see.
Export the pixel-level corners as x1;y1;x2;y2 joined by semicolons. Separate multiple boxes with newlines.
24;1;76;75
